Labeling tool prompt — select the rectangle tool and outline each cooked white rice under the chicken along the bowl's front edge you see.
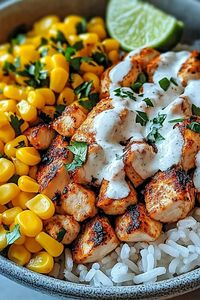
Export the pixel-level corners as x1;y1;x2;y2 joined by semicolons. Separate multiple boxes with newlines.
61;208;200;287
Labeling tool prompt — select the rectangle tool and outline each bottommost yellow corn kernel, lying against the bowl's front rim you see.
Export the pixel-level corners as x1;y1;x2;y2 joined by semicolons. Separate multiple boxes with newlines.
26;251;54;274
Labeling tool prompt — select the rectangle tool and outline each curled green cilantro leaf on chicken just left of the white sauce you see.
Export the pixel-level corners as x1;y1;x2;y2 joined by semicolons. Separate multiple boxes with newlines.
65;141;87;171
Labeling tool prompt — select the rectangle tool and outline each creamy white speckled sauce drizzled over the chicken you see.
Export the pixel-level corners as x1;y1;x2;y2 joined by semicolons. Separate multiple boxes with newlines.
81;50;200;199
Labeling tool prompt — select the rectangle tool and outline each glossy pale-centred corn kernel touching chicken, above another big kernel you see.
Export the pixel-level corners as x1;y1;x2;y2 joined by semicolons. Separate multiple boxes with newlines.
26;194;55;220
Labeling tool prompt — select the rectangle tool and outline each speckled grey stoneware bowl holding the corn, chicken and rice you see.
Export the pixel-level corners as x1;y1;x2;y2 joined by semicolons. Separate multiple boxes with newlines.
0;0;200;299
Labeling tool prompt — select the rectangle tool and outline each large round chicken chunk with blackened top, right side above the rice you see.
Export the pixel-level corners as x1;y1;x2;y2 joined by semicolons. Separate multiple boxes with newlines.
144;167;195;223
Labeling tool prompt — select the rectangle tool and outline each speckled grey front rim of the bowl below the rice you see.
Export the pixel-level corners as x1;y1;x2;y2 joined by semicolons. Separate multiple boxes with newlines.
0;256;200;299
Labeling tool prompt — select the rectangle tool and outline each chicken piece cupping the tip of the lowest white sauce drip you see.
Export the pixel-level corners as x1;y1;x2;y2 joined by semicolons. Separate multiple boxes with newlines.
97;180;137;215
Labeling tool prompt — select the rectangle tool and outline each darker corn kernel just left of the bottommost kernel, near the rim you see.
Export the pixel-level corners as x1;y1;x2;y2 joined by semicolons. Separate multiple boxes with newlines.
8;244;31;266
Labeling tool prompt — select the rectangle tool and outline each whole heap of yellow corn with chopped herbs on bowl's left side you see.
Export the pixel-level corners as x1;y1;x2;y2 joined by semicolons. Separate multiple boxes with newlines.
0;15;120;274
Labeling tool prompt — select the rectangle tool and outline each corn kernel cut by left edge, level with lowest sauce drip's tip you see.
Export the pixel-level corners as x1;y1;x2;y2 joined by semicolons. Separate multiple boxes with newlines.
0;183;20;205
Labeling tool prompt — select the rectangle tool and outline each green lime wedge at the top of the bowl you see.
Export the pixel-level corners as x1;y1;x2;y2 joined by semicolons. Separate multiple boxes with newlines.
106;0;184;51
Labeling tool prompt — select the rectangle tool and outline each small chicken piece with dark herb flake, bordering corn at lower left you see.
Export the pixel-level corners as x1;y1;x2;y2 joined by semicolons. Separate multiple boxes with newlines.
44;215;80;245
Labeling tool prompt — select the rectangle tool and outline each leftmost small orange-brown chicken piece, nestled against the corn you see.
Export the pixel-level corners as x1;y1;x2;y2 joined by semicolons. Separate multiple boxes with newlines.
24;124;55;150
